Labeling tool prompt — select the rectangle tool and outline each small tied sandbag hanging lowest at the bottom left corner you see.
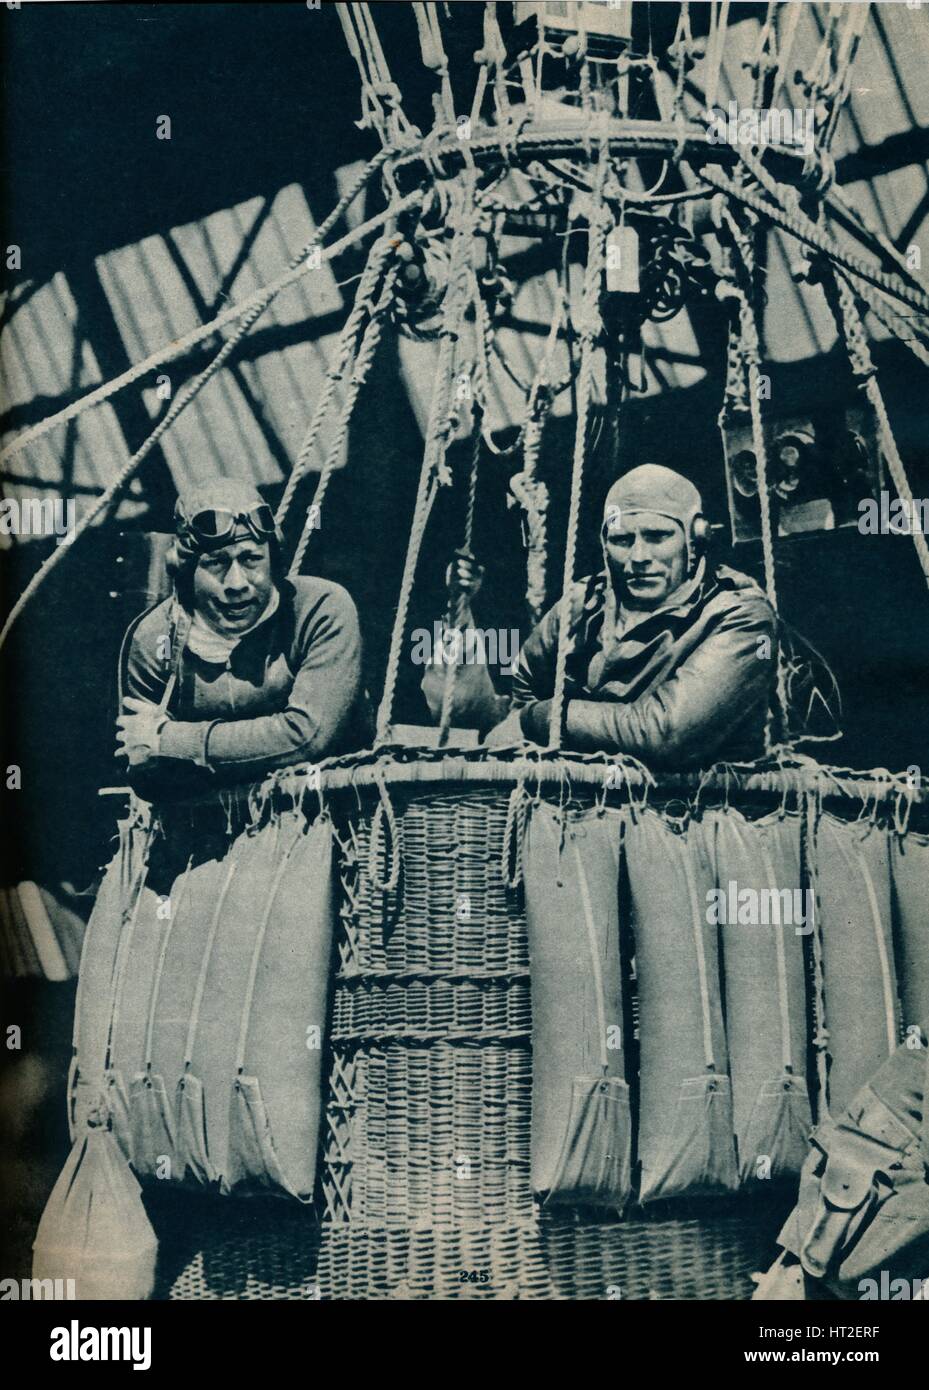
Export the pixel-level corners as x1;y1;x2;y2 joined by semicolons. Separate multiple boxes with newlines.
32;1126;157;1301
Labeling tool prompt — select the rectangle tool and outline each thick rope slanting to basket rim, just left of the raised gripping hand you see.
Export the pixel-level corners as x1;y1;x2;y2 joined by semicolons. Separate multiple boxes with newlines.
375;193;474;744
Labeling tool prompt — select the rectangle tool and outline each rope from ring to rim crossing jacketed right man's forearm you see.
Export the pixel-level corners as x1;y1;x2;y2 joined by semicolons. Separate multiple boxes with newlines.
548;146;608;748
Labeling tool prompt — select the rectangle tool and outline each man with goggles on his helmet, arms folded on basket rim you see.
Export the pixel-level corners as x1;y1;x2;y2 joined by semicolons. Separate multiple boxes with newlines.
117;478;369;795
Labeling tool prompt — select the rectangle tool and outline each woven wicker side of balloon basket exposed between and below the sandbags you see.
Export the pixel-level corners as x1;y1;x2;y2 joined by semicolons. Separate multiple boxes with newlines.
150;763;806;1300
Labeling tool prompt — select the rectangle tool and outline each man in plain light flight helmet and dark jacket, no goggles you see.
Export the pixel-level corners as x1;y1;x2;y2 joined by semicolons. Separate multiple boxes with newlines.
423;463;777;767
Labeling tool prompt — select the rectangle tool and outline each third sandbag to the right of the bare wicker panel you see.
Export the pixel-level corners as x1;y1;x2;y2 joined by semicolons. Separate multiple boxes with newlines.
702;808;812;1184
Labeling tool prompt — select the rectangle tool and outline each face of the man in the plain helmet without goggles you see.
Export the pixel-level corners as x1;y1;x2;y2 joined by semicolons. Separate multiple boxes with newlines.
606;512;687;610
